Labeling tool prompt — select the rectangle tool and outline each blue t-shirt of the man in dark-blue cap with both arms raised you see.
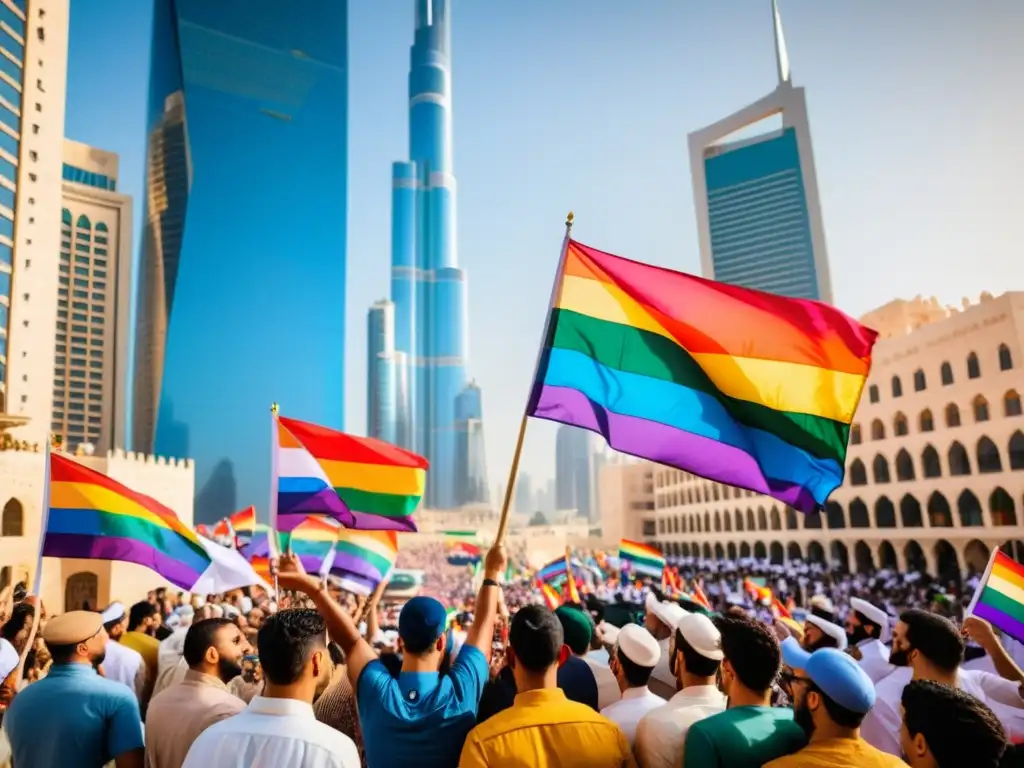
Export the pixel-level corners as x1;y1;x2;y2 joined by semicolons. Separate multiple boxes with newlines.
356;645;488;768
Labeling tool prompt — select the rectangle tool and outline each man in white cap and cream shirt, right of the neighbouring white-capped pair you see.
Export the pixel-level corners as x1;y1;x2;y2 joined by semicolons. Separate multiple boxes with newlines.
634;613;726;768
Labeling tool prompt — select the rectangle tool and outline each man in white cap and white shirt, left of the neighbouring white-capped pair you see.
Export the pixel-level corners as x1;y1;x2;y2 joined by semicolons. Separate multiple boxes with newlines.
601;624;665;746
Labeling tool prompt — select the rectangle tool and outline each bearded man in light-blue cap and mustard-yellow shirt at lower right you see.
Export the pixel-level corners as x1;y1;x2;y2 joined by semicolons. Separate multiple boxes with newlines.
765;638;903;768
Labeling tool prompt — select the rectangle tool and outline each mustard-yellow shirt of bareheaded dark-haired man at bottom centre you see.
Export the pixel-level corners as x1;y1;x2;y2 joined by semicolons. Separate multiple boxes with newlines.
459;688;634;768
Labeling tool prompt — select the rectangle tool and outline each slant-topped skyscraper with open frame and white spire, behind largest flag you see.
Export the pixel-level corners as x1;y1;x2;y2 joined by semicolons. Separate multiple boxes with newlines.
689;0;831;302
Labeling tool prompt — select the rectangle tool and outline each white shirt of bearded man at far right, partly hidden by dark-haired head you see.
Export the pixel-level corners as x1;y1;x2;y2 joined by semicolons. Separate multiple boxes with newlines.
860;667;1024;757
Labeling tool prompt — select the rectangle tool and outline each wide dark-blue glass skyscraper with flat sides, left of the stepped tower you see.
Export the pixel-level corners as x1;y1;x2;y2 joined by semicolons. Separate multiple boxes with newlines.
133;0;348;521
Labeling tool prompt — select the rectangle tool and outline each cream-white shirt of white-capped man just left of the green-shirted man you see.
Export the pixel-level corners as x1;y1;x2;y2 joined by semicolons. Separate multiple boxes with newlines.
633;685;725;768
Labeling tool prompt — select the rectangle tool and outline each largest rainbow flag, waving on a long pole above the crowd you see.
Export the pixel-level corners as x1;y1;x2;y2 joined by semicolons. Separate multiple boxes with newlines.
527;241;878;512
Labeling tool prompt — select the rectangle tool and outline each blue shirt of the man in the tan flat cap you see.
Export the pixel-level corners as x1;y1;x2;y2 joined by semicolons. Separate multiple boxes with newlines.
3;664;143;768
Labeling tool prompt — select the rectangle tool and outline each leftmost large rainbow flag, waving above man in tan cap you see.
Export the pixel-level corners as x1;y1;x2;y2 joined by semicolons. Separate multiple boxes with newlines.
42;454;210;591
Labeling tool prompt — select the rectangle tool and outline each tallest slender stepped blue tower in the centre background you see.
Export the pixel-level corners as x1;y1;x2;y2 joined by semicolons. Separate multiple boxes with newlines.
380;0;486;509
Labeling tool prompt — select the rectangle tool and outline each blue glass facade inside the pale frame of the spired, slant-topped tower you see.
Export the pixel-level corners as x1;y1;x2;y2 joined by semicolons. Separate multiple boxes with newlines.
705;128;821;299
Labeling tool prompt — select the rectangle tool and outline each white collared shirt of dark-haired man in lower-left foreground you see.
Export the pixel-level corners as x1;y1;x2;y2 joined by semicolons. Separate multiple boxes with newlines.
181;696;359;768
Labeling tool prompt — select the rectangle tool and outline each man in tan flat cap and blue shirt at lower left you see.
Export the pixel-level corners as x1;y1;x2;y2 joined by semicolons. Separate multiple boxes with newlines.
3;610;144;768
